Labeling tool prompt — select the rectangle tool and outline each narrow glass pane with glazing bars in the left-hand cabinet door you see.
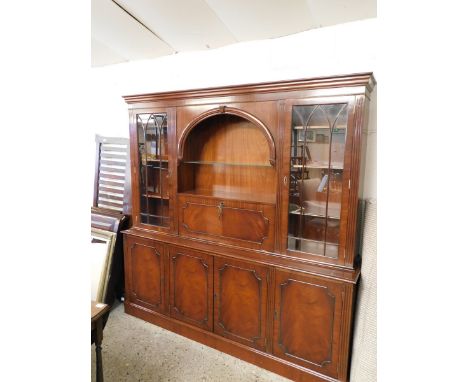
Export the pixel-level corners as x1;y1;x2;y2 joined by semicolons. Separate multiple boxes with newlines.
137;113;169;227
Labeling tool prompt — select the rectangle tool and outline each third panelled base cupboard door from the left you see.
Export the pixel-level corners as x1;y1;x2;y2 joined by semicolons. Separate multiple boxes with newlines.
214;257;269;351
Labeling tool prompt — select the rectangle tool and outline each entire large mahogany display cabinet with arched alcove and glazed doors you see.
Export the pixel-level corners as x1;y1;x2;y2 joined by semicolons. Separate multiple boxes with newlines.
124;73;375;381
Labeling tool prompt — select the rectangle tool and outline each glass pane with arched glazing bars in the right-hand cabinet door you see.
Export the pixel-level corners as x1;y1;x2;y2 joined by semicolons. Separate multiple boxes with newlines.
288;104;348;258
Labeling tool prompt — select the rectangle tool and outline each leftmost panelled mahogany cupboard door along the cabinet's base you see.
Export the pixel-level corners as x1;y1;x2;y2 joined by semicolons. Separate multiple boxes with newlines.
125;237;167;313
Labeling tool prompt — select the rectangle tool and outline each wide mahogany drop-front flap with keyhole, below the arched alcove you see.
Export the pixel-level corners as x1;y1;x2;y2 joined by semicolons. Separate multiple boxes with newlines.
179;194;275;250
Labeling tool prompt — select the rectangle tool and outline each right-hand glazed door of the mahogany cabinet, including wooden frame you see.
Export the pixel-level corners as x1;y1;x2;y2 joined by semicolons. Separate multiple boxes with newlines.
281;97;360;265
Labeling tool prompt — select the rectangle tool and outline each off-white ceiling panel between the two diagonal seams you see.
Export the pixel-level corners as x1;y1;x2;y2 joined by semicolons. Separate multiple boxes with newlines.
117;0;236;51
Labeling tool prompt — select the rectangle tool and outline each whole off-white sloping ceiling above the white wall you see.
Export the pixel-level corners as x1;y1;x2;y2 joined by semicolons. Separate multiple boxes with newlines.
91;0;376;66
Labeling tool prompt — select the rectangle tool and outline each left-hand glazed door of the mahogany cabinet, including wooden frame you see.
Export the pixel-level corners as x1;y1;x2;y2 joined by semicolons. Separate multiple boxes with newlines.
131;109;175;231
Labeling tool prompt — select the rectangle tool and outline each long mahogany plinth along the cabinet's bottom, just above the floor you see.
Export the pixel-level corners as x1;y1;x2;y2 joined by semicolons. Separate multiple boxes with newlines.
125;301;339;382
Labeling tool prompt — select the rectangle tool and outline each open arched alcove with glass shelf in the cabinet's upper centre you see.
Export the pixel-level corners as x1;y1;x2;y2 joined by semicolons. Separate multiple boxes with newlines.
178;107;276;203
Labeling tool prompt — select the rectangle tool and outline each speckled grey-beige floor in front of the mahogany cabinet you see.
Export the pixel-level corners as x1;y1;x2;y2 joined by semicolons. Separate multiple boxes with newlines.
91;304;289;382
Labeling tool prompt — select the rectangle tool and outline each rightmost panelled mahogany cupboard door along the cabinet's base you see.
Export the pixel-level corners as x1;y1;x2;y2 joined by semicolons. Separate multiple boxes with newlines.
273;270;344;378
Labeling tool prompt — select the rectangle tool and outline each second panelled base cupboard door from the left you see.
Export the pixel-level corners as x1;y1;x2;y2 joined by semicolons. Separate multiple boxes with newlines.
169;247;213;331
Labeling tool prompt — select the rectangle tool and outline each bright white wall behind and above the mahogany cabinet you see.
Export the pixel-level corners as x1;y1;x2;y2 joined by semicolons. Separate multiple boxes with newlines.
90;19;377;197
